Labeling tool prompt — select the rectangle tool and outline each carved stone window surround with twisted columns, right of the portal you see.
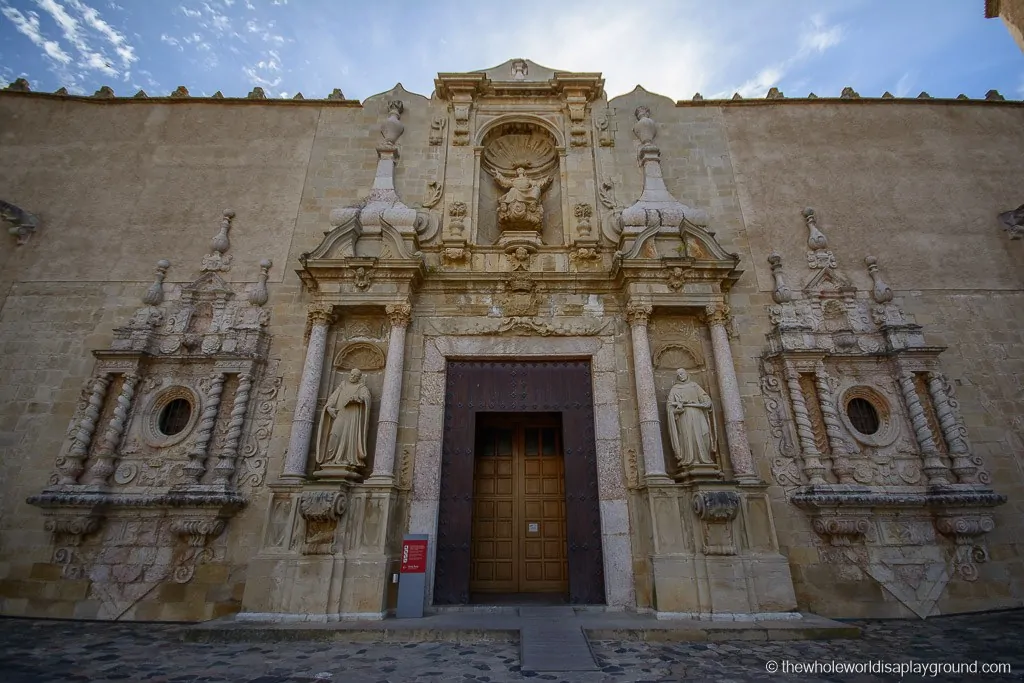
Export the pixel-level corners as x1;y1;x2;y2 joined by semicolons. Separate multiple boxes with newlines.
761;209;1006;617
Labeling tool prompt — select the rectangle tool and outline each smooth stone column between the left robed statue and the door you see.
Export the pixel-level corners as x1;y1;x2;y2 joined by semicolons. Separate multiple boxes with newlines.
368;303;413;485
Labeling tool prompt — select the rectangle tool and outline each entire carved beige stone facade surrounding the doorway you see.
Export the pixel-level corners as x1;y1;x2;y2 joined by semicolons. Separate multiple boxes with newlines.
0;59;1024;621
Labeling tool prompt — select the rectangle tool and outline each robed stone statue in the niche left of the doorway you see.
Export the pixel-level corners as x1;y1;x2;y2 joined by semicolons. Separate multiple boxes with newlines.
316;368;373;478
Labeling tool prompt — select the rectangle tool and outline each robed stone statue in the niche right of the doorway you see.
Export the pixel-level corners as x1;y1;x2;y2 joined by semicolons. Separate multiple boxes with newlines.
667;369;718;468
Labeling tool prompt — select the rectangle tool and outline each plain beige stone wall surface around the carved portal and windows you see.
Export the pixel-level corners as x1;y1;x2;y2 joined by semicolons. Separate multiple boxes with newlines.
0;90;1024;618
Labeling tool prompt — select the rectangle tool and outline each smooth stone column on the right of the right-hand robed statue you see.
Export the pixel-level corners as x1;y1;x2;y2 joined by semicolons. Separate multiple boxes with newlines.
705;303;761;483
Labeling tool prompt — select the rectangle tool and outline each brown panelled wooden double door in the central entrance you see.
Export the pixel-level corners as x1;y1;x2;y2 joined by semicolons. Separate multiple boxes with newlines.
469;413;568;597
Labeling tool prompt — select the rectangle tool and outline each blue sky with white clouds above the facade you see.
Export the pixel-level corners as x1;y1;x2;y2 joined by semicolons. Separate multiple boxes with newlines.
0;0;1024;100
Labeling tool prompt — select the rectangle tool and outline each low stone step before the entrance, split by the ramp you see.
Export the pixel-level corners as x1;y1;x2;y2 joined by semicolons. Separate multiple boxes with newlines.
182;611;861;643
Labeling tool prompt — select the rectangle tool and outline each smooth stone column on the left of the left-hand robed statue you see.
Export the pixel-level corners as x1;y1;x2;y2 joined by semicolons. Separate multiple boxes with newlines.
281;304;333;481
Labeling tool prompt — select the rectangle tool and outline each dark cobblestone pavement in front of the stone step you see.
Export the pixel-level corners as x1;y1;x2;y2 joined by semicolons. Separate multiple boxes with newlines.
0;610;1024;683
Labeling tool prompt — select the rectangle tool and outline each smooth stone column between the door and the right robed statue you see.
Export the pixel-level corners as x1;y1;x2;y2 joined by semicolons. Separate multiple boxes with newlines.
626;301;671;483
